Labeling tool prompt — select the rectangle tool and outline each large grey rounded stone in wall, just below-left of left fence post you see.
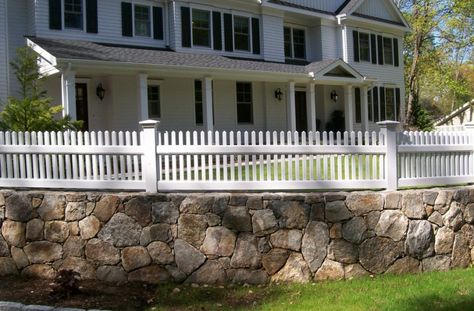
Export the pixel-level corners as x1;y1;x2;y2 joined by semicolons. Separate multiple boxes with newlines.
96;213;142;247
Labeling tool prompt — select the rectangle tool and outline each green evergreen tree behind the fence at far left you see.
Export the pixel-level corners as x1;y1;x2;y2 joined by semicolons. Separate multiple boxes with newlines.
0;47;82;132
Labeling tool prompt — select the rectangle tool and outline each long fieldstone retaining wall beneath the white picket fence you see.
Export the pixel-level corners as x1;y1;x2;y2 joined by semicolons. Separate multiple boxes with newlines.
0;187;474;284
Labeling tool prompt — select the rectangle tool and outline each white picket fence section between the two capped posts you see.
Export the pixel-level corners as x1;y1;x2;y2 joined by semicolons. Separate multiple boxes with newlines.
157;131;386;191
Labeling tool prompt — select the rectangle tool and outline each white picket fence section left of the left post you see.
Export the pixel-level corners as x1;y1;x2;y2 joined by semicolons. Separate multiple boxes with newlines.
0;131;144;190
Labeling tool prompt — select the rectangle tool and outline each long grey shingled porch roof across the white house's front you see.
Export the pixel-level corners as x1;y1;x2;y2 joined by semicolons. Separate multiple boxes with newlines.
27;37;363;83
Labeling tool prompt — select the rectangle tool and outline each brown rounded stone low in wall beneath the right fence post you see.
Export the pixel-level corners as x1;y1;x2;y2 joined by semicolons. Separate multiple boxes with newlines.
359;237;403;274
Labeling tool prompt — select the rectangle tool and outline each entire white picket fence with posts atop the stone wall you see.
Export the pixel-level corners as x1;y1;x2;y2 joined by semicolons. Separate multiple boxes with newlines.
0;121;474;192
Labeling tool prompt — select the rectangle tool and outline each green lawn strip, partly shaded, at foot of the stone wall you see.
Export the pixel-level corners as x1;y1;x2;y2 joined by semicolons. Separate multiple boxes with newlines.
149;269;474;311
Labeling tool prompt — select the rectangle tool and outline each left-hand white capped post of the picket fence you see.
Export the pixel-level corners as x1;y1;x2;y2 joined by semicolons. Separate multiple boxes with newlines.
140;120;160;192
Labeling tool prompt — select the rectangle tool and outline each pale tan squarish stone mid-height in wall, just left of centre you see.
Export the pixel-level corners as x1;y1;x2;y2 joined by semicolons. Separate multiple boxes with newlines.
201;227;236;258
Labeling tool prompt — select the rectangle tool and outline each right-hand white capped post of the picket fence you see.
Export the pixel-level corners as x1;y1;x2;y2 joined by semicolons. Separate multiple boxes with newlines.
377;121;399;191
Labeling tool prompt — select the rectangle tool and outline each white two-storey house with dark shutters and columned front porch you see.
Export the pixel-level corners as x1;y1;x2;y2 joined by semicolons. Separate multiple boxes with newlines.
0;0;409;131
